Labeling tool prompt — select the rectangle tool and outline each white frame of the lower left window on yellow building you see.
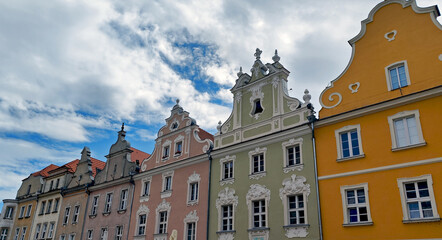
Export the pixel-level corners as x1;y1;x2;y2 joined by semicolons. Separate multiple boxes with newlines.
341;183;373;226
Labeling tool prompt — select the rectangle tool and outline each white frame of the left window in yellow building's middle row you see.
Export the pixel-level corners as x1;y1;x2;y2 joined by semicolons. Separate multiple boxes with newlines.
335;124;365;161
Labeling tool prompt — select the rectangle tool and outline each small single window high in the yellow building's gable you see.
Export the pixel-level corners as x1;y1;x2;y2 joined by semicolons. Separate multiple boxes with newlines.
385;61;410;91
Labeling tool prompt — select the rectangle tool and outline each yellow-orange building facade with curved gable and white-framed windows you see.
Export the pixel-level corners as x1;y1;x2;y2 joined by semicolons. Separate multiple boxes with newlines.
315;0;442;239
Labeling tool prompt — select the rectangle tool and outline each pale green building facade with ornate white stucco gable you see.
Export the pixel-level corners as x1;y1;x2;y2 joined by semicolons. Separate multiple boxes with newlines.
209;49;319;240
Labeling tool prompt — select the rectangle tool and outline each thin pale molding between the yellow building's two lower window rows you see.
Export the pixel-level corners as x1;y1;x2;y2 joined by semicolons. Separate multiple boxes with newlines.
318;157;442;180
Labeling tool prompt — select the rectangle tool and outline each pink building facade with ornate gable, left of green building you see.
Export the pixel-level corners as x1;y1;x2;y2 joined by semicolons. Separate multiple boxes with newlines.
128;100;213;240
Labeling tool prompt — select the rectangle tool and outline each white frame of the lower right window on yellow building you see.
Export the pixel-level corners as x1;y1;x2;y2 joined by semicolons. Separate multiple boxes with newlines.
397;174;440;223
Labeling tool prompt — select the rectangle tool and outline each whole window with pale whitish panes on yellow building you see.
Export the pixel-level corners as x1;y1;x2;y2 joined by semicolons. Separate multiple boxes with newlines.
388;110;425;150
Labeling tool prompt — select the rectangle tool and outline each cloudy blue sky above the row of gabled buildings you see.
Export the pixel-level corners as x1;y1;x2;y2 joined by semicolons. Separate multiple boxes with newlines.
0;0;442;206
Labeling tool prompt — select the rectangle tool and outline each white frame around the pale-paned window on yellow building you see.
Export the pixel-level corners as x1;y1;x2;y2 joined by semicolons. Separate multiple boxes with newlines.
388;110;426;151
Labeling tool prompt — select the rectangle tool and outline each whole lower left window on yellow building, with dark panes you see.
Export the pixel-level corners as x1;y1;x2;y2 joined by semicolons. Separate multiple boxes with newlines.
341;183;373;225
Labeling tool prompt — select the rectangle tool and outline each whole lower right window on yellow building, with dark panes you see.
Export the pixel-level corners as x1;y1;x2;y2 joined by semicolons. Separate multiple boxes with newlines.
398;175;439;222
